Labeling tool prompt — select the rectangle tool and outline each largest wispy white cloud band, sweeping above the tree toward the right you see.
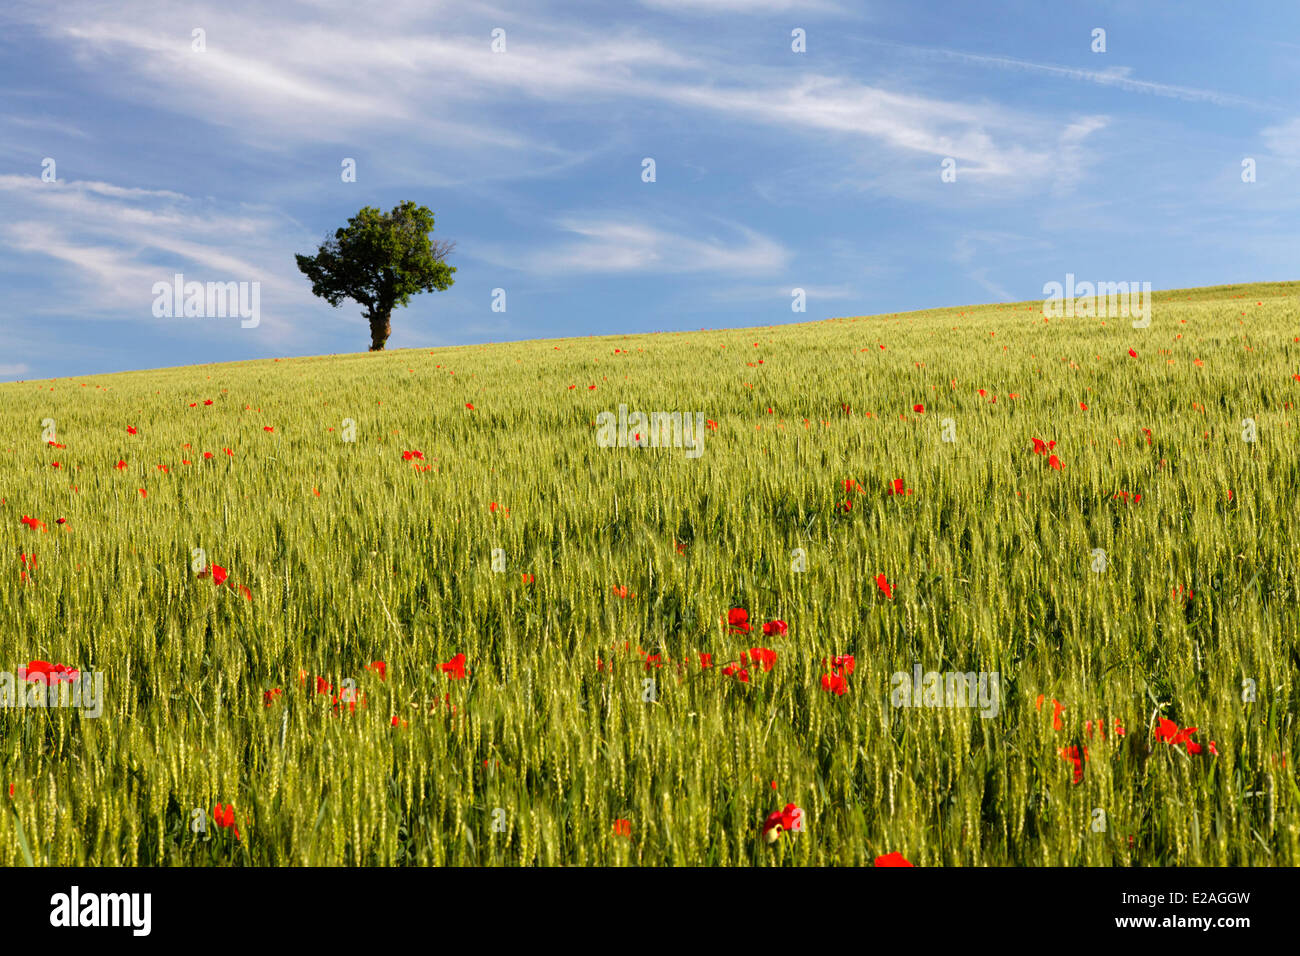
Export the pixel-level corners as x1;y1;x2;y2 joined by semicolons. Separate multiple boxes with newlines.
17;0;1086;182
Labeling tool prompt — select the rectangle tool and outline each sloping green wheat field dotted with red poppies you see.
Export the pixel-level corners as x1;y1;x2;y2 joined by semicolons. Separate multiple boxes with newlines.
0;282;1300;866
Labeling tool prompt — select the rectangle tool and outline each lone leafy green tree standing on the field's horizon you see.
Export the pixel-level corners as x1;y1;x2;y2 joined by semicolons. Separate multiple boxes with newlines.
294;200;456;352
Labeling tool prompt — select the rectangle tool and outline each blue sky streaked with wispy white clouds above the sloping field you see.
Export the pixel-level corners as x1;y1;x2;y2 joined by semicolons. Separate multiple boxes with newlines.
0;0;1300;381
